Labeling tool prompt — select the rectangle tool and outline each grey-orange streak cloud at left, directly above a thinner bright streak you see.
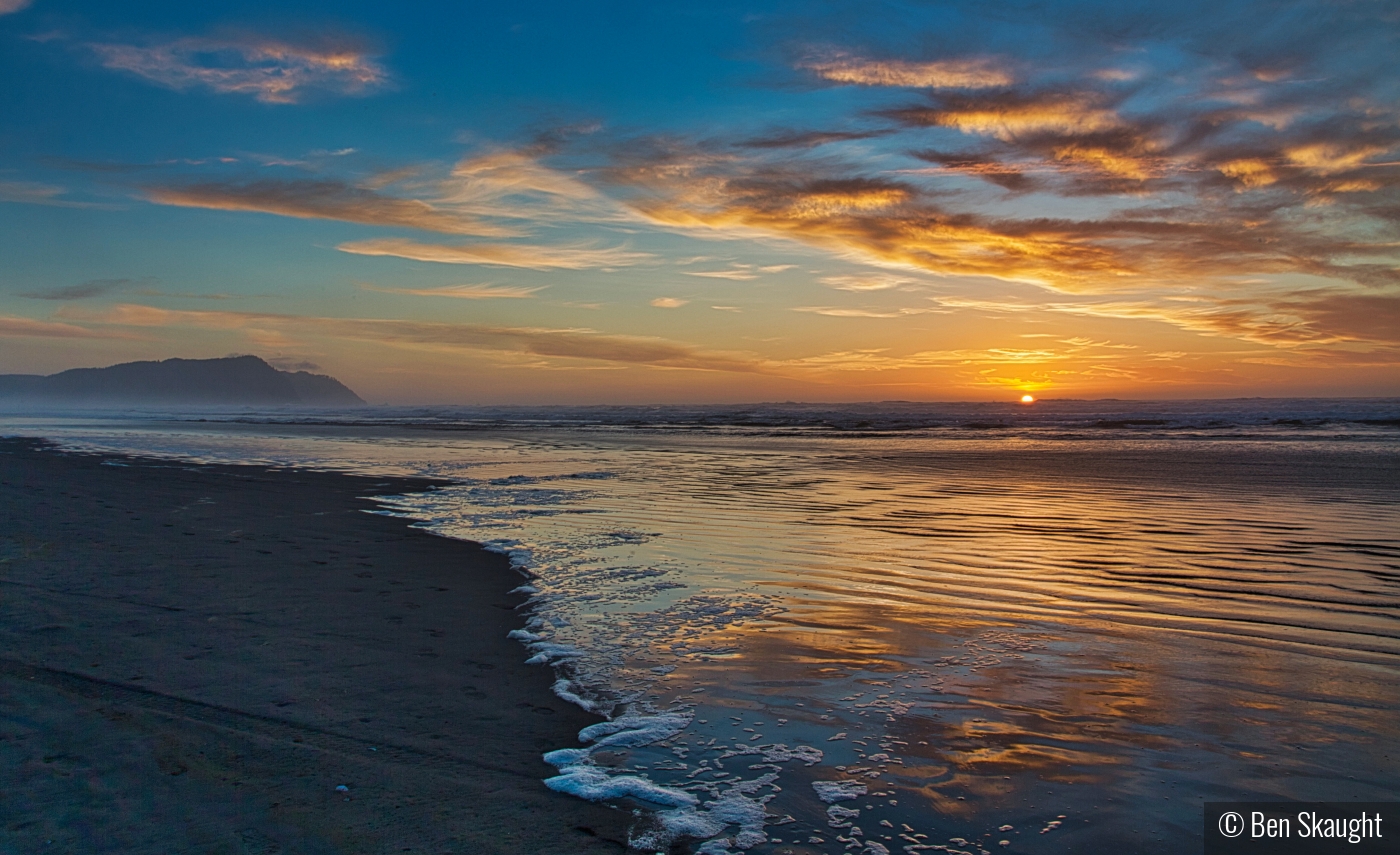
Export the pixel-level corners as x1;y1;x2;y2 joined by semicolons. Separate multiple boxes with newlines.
144;179;521;238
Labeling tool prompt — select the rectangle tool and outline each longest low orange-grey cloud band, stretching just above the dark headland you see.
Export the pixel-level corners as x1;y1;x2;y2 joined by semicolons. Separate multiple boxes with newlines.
57;304;766;374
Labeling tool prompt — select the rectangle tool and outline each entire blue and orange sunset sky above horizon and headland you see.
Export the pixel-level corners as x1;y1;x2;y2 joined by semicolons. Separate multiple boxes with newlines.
0;0;1400;404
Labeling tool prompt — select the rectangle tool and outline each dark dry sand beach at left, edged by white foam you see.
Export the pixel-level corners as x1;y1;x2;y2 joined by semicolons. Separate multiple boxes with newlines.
0;439;631;855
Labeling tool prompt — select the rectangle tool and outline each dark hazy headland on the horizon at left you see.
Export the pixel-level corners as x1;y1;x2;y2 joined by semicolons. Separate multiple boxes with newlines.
0;357;364;407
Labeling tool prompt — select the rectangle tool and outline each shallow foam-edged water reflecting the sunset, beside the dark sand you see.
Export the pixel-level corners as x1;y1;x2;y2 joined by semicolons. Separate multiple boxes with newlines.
10;403;1400;855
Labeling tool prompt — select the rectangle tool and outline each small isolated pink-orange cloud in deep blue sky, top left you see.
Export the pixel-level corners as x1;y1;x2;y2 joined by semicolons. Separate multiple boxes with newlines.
88;35;389;104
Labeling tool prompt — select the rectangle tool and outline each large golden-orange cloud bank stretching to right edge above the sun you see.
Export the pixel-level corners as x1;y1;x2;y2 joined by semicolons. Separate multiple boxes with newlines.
606;118;1400;294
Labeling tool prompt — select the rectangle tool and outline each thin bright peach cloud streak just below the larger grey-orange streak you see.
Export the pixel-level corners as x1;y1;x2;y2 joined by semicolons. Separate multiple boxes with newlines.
336;238;651;270
